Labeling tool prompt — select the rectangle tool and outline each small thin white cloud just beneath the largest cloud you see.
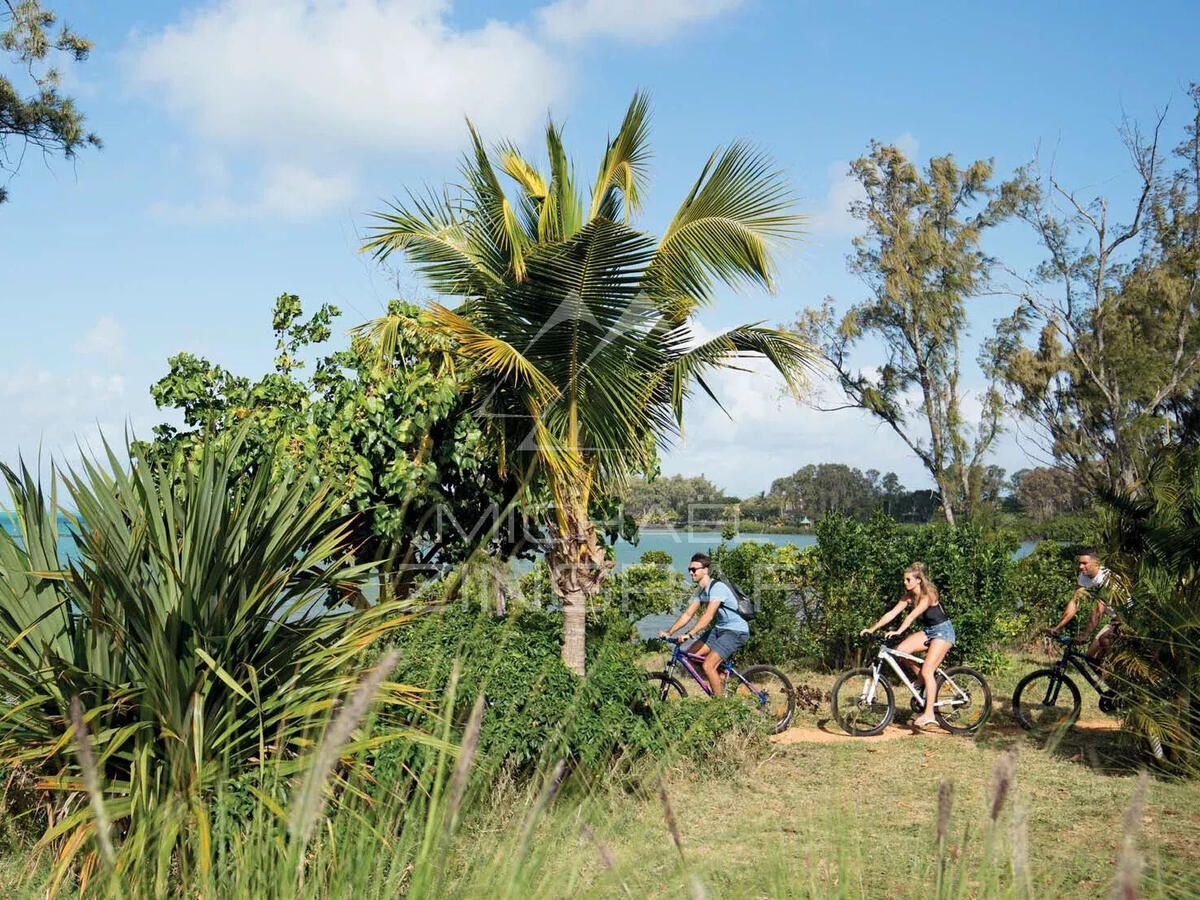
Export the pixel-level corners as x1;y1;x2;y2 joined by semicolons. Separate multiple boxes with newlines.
150;163;354;224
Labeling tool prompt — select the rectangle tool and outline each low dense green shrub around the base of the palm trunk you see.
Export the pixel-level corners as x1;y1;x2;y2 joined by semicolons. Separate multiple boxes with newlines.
376;604;746;784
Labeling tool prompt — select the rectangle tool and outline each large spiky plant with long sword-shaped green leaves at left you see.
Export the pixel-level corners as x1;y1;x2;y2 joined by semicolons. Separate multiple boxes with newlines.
0;438;427;874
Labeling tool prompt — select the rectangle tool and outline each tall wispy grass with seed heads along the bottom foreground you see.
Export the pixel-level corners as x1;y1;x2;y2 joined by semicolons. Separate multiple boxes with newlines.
9;667;1180;900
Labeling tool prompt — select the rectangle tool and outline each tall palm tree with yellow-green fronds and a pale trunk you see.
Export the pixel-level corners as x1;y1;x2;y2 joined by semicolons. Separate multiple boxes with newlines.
364;94;816;674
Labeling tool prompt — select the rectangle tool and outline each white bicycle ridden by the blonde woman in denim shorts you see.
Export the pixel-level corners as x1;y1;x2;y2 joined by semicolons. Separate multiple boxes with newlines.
832;642;991;738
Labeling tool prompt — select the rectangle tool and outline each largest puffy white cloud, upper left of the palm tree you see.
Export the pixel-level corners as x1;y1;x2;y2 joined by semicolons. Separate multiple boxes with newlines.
130;0;565;160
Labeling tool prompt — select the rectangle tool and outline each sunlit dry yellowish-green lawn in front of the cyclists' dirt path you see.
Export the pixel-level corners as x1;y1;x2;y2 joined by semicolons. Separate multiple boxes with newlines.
458;655;1200;898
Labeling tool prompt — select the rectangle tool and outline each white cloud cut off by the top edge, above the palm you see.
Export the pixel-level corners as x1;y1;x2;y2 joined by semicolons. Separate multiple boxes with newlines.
538;0;743;43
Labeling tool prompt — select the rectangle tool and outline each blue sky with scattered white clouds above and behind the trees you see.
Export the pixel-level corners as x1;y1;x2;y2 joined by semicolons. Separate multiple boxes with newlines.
0;0;1200;496
